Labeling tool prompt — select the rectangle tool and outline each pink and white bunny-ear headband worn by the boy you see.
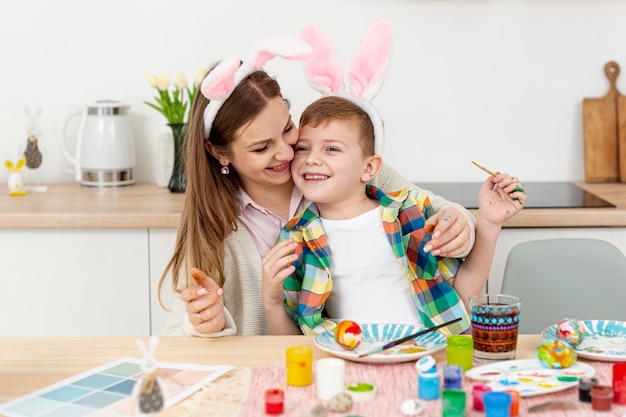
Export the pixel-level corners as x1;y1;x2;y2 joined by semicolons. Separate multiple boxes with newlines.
301;20;391;155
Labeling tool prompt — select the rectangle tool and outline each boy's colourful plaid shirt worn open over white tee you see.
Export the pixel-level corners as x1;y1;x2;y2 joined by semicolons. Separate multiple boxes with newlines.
278;186;470;334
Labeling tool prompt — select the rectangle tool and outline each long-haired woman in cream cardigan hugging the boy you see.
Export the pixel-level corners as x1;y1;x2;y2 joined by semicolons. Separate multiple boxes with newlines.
159;38;475;337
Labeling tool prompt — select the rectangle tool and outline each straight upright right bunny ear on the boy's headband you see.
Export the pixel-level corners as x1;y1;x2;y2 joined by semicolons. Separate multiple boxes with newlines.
349;20;391;101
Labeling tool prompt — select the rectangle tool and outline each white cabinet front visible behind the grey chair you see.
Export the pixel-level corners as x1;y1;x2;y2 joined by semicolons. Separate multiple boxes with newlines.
487;228;626;293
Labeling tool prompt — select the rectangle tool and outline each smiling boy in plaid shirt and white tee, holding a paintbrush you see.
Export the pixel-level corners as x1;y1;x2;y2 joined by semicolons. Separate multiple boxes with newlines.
262;96;526;334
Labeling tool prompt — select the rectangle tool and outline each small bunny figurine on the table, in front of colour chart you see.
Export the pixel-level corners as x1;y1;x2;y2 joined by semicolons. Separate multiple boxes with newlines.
132;336;165;415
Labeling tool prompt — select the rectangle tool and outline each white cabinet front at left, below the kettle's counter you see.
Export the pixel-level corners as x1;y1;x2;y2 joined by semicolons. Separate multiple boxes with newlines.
0;229;150;336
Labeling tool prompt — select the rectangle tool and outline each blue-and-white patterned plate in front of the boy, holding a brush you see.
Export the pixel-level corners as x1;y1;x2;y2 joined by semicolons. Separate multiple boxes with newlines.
315;324;446;363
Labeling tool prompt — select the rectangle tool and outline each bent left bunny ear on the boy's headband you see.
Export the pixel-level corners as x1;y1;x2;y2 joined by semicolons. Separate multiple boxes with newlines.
300;26;343;95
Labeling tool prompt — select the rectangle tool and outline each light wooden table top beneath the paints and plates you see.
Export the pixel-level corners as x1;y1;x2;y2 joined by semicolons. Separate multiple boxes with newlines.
0;335;626;417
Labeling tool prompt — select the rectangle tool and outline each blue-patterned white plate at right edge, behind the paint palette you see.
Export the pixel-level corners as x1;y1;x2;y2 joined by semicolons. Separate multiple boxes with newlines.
541;320;626;362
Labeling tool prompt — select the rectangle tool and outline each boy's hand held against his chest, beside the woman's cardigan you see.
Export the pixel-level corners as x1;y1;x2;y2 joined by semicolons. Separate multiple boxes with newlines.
261;239;298;310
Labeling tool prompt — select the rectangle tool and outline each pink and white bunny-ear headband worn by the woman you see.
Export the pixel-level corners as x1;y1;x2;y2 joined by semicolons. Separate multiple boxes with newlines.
200;35;311;139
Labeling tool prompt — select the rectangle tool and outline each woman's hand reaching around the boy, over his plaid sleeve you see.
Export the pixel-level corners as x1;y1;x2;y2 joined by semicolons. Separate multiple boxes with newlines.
424;207;471;258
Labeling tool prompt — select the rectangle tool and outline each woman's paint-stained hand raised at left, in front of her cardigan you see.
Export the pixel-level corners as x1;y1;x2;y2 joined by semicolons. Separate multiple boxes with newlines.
180;268;226;333
